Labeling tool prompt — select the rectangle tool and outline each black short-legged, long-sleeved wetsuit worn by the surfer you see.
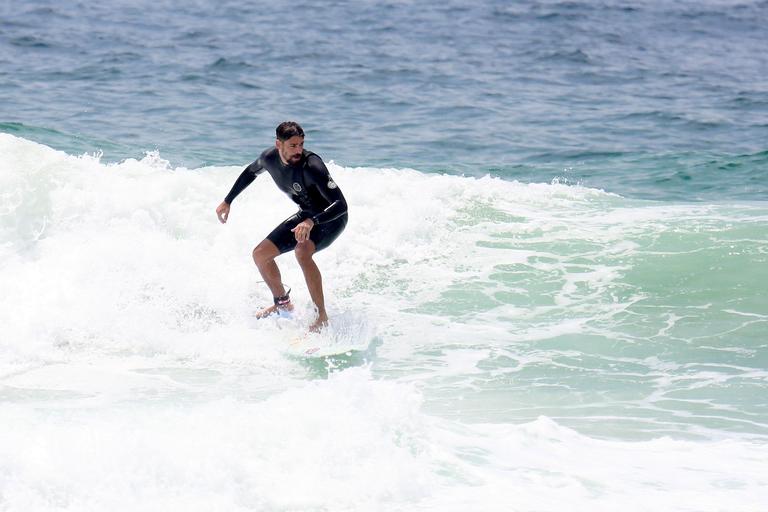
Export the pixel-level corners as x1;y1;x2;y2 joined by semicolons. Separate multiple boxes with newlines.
224;148;347;253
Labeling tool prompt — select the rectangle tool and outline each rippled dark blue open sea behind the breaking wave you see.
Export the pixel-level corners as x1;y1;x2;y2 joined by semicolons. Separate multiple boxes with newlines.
0;0;768;201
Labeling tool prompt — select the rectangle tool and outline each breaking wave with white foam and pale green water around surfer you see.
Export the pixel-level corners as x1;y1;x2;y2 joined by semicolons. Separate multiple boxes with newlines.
0;134;768;512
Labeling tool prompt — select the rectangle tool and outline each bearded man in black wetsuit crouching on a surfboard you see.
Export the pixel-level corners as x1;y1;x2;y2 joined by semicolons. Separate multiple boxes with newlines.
216;121;347;331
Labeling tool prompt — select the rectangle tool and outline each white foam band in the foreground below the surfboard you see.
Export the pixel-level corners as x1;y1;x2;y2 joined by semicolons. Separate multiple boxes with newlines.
0;369;768;511
